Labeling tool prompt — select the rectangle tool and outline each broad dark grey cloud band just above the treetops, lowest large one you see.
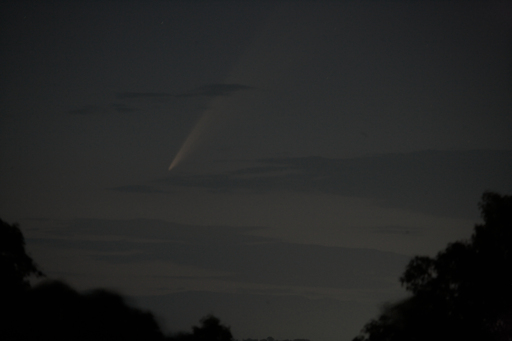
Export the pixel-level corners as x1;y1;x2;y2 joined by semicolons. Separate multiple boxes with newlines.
31;219;408;290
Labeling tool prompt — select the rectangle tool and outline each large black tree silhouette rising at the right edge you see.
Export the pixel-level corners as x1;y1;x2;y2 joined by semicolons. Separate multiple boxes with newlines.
354;192;512;341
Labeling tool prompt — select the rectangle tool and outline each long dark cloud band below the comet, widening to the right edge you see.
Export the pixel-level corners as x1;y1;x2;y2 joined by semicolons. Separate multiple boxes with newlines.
161;150;512;219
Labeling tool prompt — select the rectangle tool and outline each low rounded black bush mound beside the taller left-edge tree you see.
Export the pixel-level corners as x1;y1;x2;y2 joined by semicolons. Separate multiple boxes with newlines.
2;281;168;341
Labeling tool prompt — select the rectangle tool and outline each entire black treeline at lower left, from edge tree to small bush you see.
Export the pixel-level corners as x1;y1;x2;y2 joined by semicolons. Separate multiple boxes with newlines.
0;220;233;341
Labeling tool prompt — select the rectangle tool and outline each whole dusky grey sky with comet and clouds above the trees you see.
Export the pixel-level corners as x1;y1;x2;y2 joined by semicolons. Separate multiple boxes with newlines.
0;1;512;341
